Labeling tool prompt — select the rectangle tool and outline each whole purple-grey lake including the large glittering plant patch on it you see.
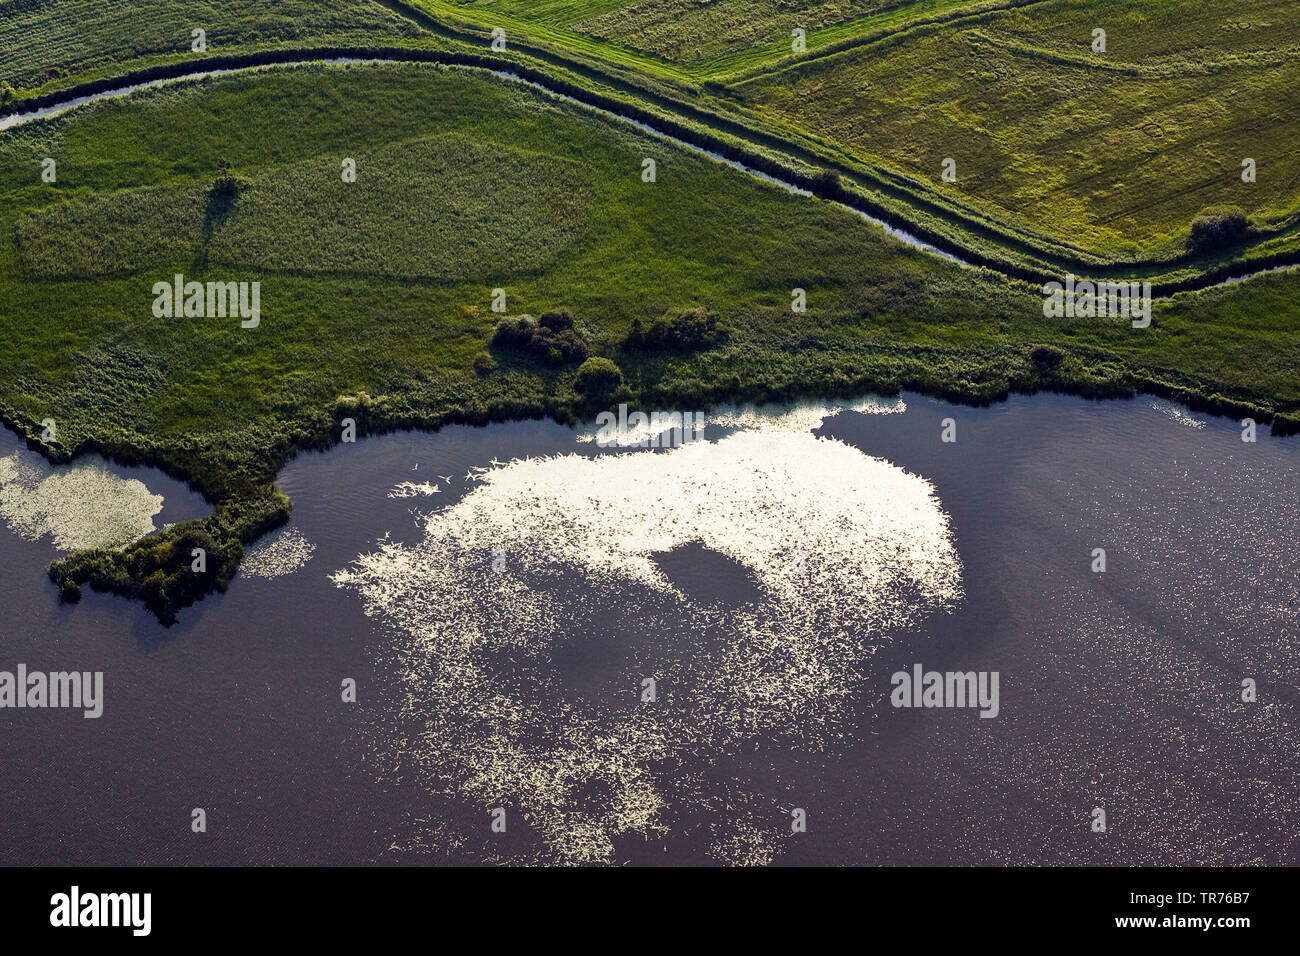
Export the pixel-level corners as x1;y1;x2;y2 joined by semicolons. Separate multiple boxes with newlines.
0;394;1300;865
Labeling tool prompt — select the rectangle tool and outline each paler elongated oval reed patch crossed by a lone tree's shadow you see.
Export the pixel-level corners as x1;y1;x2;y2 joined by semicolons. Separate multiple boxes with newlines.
16;135;590;281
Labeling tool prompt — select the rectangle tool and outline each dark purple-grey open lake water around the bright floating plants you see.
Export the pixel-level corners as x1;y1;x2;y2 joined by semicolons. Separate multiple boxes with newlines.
0;394;1300;865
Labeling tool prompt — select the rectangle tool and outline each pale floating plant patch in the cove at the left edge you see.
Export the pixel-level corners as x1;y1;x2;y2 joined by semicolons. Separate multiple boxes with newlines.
0;451;163;551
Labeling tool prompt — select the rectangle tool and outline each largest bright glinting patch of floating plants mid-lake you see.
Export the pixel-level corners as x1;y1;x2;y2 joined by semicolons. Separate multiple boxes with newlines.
333;407;961;862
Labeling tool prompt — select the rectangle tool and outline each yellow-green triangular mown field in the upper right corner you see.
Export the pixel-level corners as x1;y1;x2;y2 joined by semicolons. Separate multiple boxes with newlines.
737;0;1300;256
